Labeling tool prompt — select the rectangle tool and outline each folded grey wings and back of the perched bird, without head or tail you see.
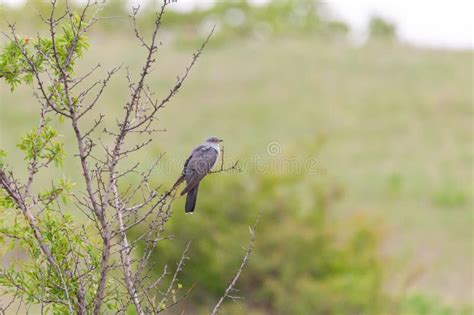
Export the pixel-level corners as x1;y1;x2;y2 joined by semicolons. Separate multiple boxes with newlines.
181;145;219;195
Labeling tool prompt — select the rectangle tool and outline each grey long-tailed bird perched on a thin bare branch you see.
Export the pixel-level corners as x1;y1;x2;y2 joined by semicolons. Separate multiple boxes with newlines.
173;137;223;213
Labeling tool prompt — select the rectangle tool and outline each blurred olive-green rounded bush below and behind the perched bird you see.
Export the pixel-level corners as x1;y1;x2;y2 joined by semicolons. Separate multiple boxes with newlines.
142;168;386;314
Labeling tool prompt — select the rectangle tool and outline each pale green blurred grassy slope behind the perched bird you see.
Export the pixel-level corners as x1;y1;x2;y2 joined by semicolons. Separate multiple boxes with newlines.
0;38;473;302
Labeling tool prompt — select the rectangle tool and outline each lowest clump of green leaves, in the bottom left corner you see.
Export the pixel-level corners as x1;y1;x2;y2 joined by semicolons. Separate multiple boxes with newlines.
0;209;117;314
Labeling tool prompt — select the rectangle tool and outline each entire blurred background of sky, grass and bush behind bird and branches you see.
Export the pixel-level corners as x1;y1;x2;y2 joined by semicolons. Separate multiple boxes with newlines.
0;0;474;315
